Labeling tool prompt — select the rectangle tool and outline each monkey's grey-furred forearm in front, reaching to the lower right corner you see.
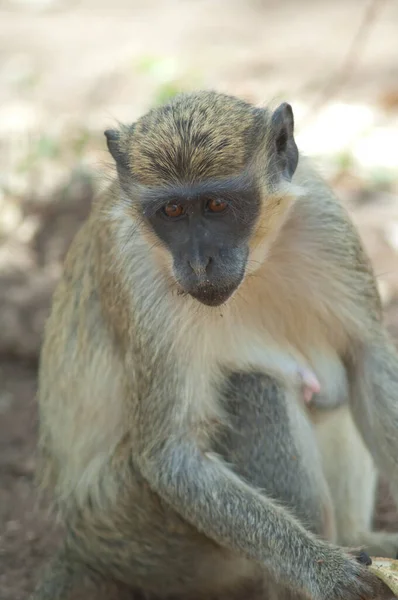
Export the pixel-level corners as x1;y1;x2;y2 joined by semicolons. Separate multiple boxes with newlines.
134;384;376;599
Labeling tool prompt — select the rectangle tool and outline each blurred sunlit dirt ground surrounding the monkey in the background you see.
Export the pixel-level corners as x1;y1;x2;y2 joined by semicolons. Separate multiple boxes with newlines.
0;0;398;600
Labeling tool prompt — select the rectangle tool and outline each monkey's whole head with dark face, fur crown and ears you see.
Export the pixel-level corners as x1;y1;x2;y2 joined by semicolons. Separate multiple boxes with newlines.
105;92;298;306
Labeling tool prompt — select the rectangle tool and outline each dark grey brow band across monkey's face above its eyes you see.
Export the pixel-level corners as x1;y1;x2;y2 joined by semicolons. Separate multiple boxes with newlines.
140;175;255;208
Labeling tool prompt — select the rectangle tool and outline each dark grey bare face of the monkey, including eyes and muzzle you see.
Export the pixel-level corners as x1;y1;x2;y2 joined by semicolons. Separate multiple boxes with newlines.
144;181;259;306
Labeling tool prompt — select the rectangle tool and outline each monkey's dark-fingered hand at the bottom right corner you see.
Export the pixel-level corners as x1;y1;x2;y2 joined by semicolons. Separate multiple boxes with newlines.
314;549;397;600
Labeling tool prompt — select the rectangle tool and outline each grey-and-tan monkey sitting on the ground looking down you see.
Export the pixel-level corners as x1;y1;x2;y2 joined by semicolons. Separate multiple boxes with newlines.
28;90;398;600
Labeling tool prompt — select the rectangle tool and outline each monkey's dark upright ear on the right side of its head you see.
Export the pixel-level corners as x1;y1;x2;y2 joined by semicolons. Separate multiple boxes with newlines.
271;102;299;179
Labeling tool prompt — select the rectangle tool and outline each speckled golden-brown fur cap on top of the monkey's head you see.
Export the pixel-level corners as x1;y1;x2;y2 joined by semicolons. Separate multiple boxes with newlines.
121;92;259;185
